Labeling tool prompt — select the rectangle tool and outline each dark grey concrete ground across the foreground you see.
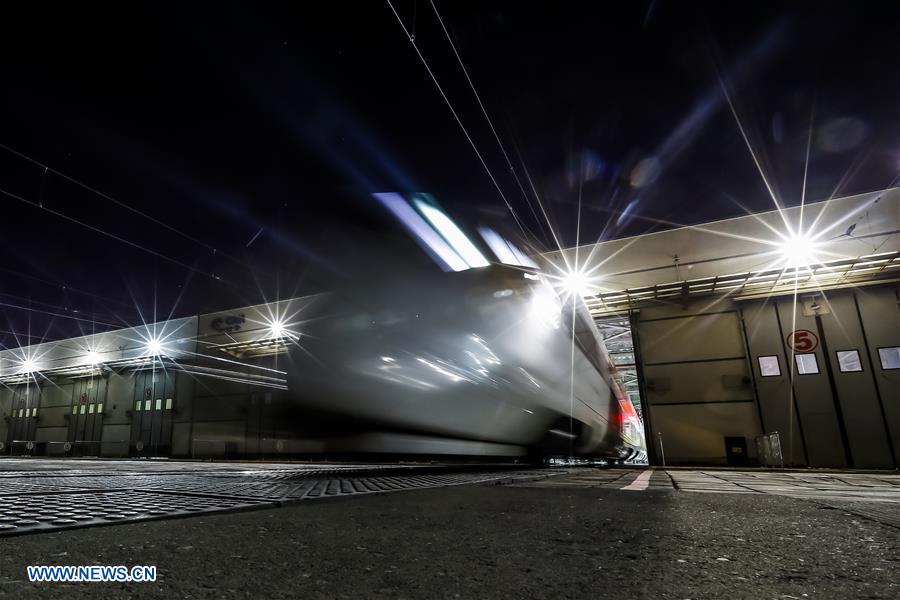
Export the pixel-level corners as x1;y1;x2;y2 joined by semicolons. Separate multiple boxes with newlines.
0;470;900;599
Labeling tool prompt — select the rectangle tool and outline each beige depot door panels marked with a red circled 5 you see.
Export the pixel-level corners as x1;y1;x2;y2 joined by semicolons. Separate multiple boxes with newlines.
633;284;900;469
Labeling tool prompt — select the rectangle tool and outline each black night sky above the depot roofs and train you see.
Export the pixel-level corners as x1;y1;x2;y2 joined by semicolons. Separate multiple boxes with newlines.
0;0;900;346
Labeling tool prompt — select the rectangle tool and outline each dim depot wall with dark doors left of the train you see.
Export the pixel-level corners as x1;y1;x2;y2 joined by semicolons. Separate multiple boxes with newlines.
0;360;304;458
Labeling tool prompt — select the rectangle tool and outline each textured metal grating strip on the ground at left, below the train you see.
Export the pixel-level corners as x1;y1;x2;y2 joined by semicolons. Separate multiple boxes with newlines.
0;469;550;536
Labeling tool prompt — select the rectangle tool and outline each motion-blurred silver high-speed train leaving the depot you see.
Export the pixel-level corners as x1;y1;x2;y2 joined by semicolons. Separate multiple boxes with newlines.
288;194;643;460
